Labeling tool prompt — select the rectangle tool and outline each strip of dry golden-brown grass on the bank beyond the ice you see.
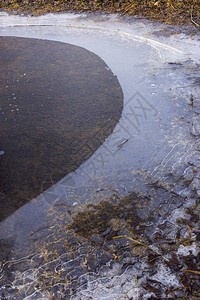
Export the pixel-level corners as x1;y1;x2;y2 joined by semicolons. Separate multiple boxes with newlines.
0;0;200;28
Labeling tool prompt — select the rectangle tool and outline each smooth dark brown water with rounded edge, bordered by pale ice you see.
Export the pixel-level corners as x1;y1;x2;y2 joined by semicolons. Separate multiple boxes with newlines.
0;37;123;220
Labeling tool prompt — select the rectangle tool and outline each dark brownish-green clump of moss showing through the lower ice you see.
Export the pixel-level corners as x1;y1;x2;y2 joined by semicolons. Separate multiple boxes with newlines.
69;193;141;237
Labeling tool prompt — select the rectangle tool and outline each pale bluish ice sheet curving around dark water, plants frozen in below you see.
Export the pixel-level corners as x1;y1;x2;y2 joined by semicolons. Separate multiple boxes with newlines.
0;14;200;299
